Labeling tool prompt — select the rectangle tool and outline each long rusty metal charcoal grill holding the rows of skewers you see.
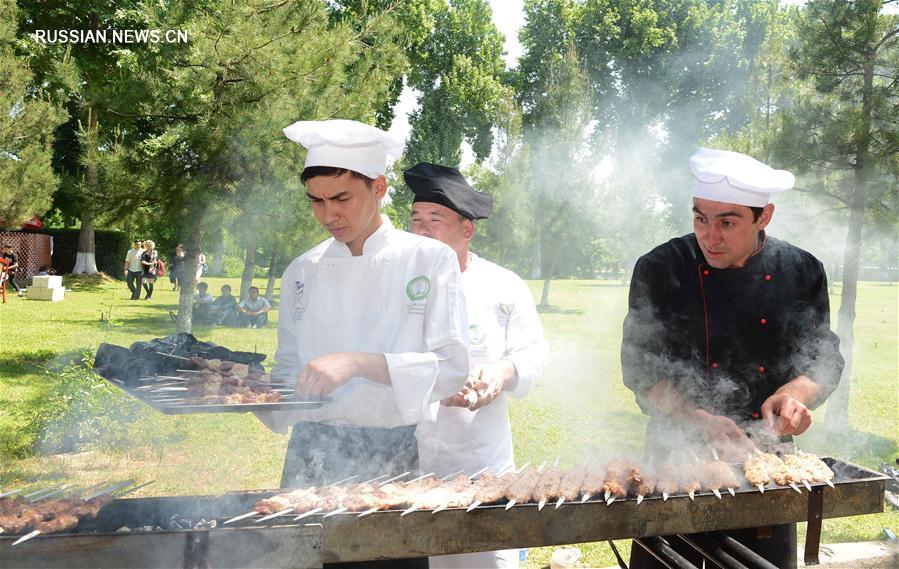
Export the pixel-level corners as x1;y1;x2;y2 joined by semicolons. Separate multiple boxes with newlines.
0;459;887;568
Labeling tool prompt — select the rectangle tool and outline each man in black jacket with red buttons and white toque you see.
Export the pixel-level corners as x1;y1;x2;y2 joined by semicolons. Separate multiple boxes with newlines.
621;148;843;568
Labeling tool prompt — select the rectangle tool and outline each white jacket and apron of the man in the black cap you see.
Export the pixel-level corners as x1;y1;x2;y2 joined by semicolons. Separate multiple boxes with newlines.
416;253;549;569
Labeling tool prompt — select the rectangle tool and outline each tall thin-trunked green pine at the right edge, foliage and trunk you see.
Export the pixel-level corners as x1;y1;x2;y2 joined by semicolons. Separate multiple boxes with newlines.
779;0;899;432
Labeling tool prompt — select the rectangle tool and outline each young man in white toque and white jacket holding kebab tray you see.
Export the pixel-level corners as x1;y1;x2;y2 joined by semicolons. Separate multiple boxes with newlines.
260;124;468;566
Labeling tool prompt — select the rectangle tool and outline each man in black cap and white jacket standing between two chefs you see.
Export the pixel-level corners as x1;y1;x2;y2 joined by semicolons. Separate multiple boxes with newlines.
403;163;549;569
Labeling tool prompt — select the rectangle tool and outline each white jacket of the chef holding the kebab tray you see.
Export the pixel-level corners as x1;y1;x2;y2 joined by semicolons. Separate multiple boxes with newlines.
268;216;468;432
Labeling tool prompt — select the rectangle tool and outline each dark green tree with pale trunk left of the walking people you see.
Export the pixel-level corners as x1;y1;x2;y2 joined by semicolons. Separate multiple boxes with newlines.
19;0;164;274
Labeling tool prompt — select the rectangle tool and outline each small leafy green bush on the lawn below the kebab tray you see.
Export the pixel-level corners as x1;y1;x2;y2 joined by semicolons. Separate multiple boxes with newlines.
35;353;151;454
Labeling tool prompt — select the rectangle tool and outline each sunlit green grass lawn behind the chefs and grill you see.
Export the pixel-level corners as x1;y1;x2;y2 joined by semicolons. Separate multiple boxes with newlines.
0;278;899;567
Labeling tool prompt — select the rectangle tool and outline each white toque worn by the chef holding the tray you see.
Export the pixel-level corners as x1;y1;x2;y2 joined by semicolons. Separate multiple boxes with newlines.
284;119;403;178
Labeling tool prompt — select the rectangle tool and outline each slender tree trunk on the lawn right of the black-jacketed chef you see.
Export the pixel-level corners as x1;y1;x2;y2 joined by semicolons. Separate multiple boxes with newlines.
826;59;874;433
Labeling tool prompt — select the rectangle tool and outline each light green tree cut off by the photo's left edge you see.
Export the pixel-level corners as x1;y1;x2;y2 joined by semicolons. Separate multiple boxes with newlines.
0;0;65;229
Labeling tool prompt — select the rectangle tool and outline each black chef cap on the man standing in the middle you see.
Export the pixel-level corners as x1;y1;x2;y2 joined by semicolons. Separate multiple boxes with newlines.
403;162;493;219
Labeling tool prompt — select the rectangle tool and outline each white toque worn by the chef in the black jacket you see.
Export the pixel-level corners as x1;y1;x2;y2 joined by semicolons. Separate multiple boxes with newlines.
690;148;796;207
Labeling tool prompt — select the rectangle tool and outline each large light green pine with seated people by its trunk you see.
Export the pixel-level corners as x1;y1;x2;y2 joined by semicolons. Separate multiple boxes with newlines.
135;0;406;331
